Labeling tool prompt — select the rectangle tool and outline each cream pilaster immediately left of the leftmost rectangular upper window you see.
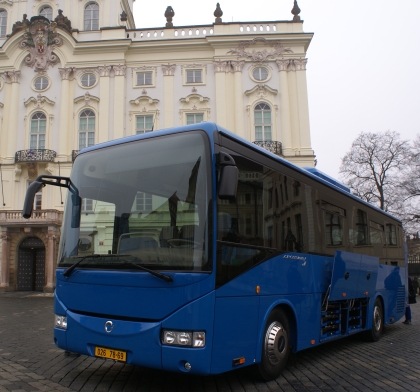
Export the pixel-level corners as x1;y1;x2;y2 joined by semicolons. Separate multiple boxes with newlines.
112;65;127;139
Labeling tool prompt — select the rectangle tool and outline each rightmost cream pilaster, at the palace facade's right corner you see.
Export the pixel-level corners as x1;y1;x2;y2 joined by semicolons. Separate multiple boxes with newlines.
295;59;313;155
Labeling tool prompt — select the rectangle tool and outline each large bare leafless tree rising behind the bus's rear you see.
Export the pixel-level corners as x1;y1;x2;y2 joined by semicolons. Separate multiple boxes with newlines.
340;131;410;214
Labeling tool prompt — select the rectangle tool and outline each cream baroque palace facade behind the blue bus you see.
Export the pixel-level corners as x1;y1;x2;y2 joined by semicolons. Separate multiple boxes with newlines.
0;0;315;292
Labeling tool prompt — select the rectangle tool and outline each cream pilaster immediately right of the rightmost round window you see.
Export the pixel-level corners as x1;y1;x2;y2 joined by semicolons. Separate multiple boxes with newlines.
276;60;293;156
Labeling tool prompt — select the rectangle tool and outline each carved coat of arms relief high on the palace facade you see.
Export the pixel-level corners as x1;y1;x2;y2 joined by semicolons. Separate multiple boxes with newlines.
19;16;63;74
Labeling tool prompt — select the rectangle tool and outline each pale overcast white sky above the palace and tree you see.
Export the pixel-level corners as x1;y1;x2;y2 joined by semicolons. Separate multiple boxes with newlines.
134;0;420;178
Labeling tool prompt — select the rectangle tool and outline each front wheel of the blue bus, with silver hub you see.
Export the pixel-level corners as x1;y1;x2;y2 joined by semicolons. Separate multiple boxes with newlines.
257;309;290;381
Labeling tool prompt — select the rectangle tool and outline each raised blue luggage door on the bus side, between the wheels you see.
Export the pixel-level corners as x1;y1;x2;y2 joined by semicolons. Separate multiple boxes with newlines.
329;251;379;301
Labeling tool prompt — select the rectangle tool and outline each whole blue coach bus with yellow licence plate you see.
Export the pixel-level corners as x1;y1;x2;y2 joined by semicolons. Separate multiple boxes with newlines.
23;122;407;380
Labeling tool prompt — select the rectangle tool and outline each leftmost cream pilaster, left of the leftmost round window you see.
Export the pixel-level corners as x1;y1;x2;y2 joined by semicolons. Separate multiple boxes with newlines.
5;71;20;160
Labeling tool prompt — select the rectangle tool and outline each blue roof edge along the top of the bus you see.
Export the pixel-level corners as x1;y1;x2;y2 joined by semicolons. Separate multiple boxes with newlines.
78;122;401;227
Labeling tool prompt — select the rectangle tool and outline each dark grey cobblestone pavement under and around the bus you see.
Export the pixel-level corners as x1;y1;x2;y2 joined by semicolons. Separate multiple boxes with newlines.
0;293;420;392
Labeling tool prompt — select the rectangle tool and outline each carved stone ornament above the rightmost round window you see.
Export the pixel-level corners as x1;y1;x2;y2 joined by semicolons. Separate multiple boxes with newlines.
227;37;293;64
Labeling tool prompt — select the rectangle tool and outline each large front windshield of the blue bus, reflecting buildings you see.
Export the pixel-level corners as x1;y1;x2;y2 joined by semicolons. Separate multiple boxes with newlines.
58;131;211;272
